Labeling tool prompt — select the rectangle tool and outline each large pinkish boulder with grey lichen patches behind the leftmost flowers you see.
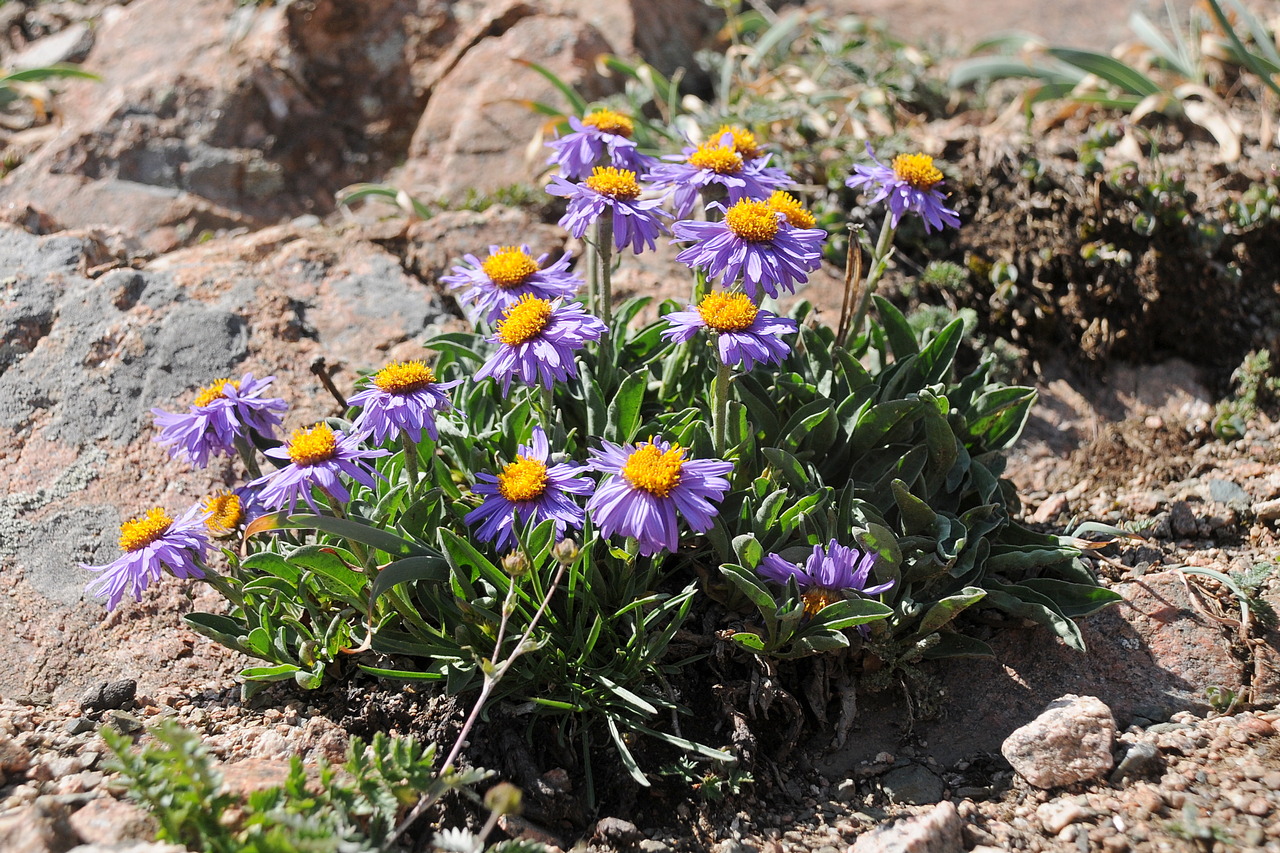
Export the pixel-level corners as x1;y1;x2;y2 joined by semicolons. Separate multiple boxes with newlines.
0;225;444;706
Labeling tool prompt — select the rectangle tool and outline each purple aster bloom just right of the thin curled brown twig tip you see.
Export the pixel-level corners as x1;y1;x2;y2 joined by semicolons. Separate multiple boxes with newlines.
348;361;462;444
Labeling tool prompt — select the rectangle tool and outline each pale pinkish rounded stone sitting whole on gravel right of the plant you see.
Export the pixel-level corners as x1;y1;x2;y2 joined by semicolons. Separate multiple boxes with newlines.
1000;694;1116;789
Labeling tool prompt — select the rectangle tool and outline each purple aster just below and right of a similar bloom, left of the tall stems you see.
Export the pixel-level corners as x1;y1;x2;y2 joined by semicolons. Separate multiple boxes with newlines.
475;296;609;393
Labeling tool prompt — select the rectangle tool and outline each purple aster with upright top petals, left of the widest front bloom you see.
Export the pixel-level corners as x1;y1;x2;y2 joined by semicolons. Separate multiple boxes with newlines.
463;427;595;551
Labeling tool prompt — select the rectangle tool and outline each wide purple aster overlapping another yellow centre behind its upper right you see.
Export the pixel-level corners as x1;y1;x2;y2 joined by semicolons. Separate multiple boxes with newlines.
673;193;827;301
